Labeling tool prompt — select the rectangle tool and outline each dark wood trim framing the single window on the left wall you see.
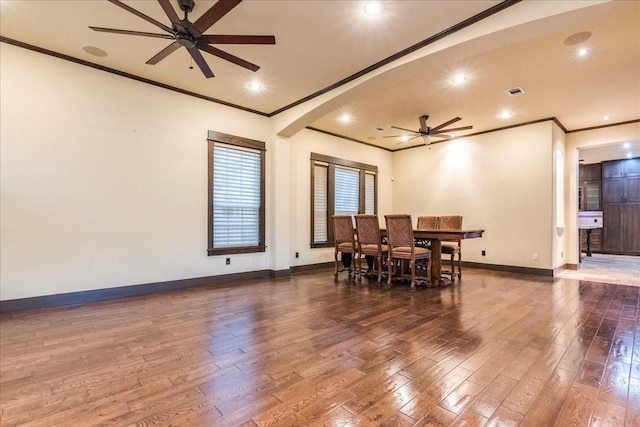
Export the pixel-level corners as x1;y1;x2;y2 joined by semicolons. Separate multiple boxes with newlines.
207;130;266;256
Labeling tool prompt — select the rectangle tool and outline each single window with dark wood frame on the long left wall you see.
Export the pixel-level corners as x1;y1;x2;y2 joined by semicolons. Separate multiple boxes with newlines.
207;131;265;255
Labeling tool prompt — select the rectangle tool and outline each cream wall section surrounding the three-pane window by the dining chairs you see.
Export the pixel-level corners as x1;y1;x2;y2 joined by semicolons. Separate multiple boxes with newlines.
289;129;392;266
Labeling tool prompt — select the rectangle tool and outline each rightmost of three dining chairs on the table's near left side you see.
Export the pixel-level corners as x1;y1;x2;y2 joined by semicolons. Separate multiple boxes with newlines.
384;214;431;292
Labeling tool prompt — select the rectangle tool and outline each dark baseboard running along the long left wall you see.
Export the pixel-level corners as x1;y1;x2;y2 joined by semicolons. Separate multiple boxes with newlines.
0;270;276;313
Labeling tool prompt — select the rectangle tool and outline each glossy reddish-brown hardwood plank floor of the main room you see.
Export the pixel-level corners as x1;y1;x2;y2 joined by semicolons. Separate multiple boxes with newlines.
0;268;640;427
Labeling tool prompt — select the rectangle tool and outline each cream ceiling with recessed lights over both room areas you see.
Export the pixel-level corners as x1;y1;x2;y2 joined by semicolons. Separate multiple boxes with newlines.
0;0;640;156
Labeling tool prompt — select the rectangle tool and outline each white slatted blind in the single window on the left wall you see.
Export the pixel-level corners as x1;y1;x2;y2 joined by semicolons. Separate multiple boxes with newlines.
213;143;262;248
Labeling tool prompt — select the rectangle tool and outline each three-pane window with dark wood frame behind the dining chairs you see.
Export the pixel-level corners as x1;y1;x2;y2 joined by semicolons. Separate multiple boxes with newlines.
311;153;378;248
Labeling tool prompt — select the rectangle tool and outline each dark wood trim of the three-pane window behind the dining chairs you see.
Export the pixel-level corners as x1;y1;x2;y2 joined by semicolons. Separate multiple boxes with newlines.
309;153;378;248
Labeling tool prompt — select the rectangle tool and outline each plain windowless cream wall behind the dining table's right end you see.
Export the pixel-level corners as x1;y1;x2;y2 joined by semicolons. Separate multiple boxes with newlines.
393;122;553;269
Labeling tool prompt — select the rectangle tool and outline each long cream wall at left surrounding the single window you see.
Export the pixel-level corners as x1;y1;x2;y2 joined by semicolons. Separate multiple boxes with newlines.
0;43;275;300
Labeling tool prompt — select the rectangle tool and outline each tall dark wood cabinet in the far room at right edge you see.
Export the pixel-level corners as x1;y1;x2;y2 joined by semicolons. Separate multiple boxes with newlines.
602;158;640;255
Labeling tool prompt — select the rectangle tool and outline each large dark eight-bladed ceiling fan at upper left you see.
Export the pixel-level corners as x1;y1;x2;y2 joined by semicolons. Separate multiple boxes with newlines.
89;0;276;78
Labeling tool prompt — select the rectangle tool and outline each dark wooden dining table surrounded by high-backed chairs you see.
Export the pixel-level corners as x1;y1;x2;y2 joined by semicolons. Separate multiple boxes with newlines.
380;229;484;286
